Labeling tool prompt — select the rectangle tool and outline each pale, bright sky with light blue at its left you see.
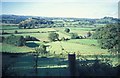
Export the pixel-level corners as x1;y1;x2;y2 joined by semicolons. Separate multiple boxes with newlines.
2;0;119;18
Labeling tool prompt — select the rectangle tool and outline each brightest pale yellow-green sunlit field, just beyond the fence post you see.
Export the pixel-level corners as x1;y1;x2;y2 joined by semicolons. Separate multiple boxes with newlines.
48;40;108;55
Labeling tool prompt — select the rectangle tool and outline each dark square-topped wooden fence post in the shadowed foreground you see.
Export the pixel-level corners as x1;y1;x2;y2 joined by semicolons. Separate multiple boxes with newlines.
68;54;76;76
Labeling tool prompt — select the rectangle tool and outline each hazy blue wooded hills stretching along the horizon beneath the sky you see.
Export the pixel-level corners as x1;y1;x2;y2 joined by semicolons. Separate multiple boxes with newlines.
0;15;120;28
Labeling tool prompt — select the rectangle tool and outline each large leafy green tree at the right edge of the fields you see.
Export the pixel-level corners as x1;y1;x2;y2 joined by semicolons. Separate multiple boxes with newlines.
94;24;120;53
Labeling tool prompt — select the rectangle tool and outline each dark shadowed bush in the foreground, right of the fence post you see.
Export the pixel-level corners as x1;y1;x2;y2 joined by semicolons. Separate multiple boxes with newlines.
77;60;118;77
